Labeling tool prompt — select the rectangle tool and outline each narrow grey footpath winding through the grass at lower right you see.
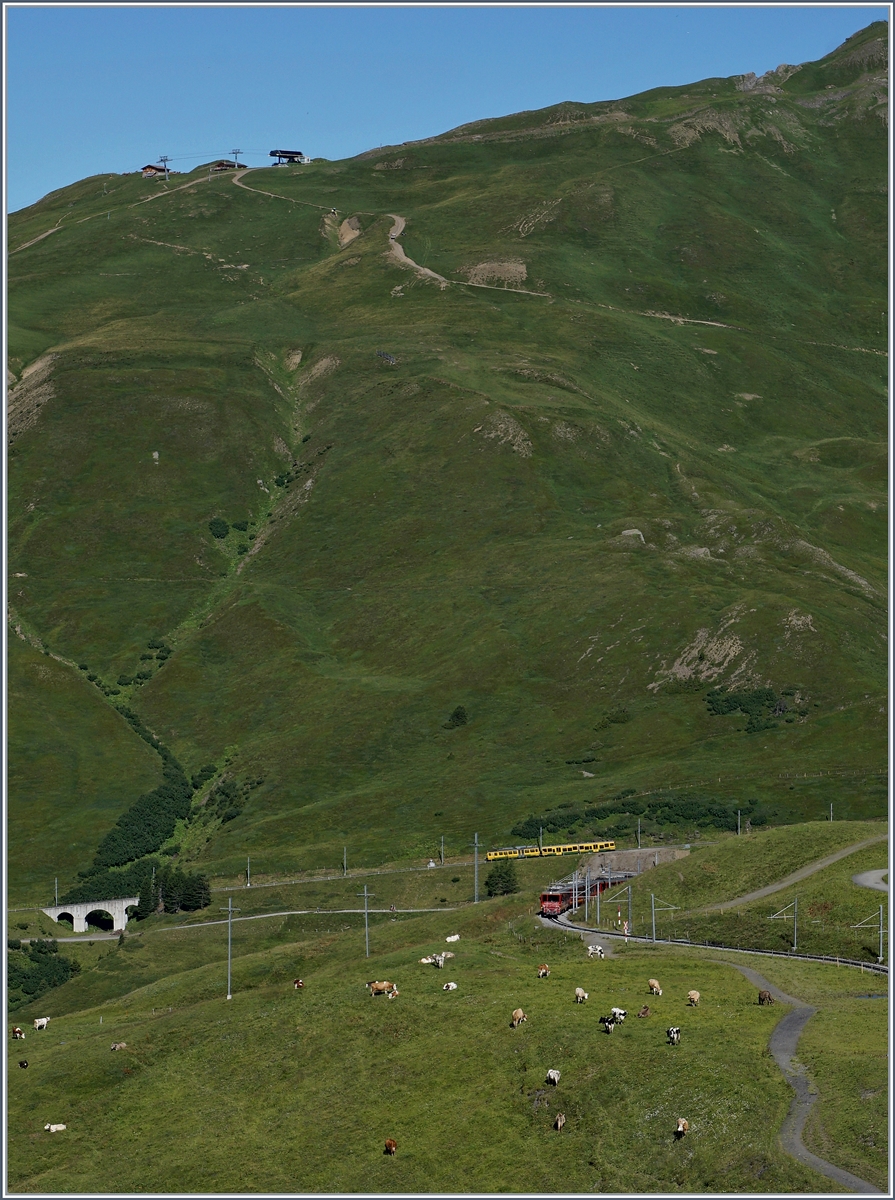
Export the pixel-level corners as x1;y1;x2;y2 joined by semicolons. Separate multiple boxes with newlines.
711;959;882;1195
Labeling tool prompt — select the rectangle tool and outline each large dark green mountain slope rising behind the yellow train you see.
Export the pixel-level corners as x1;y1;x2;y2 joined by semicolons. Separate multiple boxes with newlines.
8;23;887;904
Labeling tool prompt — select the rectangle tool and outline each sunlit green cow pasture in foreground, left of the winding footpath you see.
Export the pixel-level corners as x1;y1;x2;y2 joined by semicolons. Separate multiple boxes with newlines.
10;900;882;1193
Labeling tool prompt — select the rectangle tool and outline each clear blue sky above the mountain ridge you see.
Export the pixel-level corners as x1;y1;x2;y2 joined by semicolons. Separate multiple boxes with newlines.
5;4;888;211
